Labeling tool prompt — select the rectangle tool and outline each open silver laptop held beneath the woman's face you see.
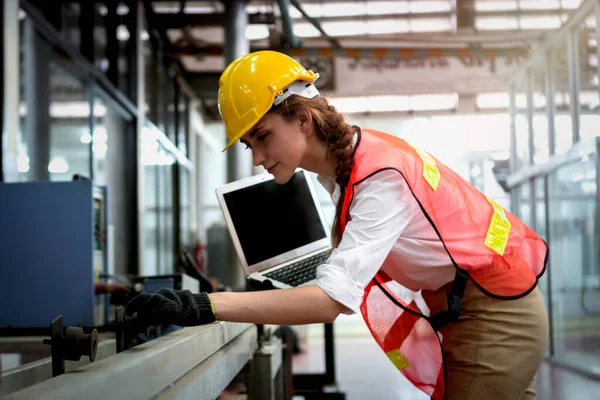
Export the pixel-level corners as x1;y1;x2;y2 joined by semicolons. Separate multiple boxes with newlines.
216;169;332;288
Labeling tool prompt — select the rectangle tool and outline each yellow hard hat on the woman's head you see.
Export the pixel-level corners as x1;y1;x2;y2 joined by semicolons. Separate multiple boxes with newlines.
219;50;319;151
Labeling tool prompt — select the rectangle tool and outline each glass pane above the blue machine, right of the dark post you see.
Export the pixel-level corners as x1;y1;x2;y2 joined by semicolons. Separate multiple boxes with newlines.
48;62;90;181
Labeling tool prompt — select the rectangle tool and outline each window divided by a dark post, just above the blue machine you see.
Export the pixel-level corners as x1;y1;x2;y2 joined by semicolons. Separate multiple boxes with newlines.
17;40;92;181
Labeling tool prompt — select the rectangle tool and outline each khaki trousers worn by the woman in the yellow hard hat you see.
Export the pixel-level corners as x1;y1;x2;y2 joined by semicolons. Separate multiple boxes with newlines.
422;280;549;400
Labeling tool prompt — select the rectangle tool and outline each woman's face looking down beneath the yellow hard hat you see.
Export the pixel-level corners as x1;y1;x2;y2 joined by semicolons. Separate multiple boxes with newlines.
240;113;307;184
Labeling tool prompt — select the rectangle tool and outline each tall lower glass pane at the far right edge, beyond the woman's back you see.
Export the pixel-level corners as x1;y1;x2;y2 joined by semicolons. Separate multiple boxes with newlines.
549;157;600;371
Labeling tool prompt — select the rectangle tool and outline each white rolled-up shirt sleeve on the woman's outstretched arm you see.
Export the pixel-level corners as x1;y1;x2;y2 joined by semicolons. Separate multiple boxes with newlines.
316;170;418;314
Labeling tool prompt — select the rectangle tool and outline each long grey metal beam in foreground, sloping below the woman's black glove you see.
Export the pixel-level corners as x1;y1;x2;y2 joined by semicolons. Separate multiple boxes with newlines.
6;322;258;400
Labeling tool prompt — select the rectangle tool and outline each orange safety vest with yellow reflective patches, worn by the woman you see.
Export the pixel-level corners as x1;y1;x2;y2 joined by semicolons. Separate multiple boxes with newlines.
340;129;548;400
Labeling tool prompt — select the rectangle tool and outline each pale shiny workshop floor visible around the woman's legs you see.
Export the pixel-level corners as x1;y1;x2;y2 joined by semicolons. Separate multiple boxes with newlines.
293;316;600;400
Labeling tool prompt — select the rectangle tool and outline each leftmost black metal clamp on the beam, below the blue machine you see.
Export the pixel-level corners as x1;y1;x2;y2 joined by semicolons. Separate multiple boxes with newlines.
43;315;98;377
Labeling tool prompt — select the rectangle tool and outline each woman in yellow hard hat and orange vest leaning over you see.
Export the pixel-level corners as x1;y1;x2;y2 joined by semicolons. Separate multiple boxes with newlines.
126;51;548;400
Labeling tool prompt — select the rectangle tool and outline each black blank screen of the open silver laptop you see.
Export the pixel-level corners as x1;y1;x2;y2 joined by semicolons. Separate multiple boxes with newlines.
223;172;327;265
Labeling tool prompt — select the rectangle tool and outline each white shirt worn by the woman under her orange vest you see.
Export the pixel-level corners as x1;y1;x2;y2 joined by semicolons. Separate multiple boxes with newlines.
316;170;455;313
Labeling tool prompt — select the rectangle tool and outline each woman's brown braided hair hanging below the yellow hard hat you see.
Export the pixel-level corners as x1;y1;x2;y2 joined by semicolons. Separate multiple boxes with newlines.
273;96;355;247
